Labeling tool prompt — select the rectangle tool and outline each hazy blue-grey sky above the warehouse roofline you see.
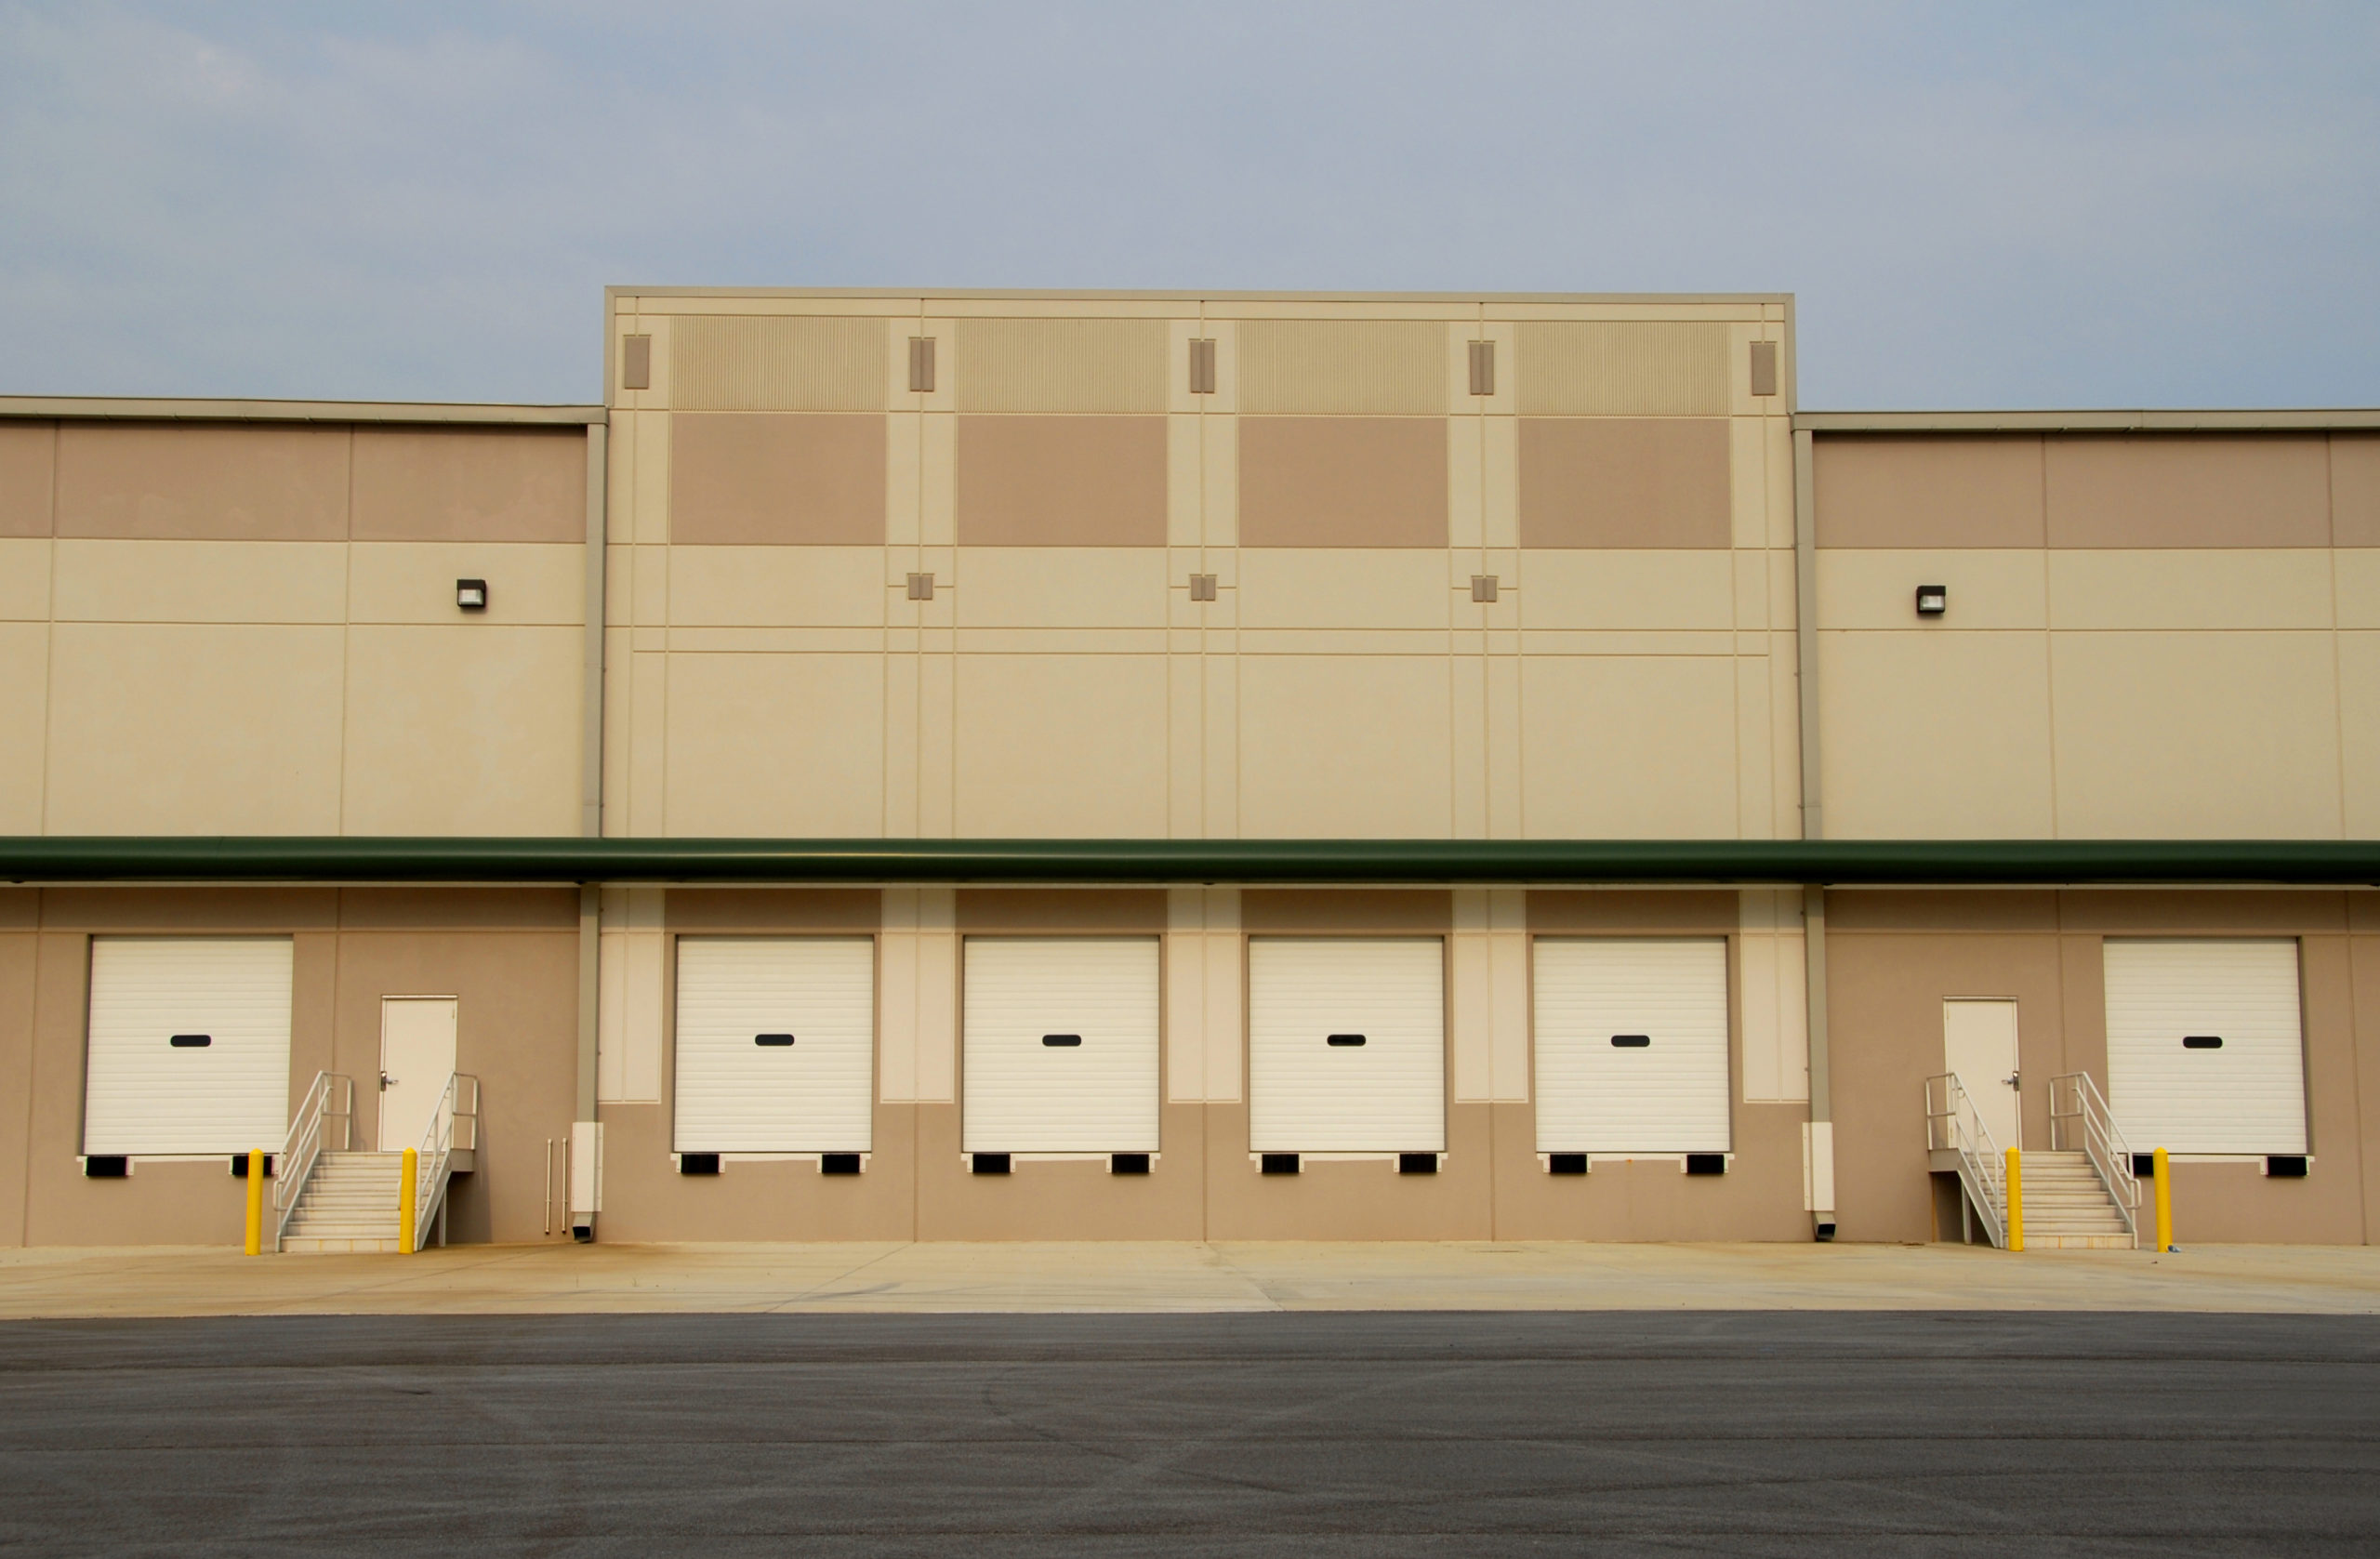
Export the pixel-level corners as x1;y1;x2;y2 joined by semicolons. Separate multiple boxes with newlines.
0;0;2380;409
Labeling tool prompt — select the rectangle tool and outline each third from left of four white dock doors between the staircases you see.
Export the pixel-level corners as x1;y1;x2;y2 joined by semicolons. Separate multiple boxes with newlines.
1247;938;1447;1152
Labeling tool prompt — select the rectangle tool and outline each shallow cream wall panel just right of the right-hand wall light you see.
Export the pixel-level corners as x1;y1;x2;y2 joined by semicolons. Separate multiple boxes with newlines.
2049;548;2333;628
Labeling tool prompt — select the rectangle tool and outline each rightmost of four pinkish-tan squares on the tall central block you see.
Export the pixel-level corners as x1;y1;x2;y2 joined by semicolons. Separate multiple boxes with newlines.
1521;416;1733;548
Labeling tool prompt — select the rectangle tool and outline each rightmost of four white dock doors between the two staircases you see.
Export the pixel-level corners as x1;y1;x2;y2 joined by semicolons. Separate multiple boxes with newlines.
1535;938;1730;1152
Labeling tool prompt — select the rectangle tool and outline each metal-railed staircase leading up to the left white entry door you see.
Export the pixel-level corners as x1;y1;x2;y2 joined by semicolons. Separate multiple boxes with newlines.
273;1071;479;1254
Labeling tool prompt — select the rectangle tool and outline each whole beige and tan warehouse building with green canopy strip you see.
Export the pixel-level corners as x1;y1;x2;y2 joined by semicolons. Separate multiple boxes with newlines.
0;290;2380;1252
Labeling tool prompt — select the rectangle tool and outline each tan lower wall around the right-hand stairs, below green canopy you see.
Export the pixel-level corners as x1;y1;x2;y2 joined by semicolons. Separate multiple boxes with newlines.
1828;891;2380;1245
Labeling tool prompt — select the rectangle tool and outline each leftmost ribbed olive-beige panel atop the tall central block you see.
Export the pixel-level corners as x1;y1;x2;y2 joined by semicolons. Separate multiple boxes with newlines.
668;314;890;412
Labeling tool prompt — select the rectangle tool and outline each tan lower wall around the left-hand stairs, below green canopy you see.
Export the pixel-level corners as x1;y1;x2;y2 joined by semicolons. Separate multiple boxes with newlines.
0;888;578;1245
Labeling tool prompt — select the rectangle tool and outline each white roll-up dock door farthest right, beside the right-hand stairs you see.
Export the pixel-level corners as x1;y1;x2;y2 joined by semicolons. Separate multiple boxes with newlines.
2107;938;2307;1155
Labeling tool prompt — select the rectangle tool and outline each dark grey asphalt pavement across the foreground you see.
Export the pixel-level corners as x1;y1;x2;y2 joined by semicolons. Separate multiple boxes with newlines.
0;1312;2380;1559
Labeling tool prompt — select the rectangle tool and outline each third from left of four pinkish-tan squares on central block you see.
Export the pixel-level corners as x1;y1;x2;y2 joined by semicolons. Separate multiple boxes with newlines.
1237;416;1447;548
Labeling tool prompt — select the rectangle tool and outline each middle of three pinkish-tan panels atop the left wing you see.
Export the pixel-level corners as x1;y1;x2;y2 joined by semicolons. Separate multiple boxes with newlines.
57;421;350;540
